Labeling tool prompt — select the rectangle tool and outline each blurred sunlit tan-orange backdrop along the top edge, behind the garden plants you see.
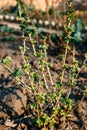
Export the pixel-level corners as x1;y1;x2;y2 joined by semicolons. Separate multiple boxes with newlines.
0;0;87;21
